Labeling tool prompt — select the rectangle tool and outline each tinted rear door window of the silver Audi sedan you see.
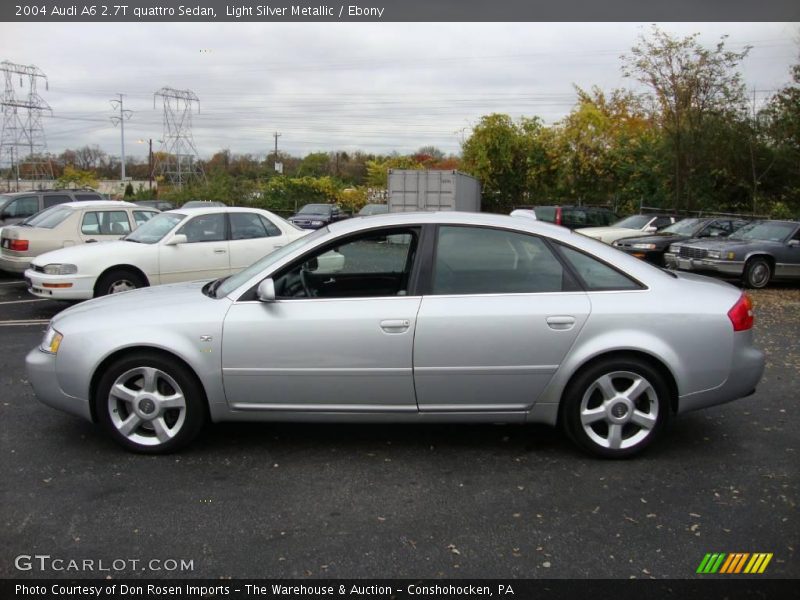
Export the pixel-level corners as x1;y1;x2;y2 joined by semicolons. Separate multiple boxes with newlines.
432;227;572;294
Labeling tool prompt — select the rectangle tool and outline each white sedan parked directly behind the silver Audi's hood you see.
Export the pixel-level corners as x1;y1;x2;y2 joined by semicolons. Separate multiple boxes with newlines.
25;207;307;300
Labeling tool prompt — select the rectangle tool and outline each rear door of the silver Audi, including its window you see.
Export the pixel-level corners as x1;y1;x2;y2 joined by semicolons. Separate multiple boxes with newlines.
414;226;590;412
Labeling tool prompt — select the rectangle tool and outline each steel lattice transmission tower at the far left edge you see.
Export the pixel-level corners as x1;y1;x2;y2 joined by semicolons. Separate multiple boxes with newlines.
0;60;53;189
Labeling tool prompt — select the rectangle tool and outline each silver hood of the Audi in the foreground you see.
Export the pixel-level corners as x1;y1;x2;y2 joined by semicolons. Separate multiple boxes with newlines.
51;282;219;324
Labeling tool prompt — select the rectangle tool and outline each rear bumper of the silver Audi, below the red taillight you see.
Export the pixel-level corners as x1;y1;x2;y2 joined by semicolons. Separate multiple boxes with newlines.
678;330;765;413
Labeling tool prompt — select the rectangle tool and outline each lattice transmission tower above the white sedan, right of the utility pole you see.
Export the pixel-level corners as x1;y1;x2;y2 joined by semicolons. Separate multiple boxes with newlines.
153;87;205;188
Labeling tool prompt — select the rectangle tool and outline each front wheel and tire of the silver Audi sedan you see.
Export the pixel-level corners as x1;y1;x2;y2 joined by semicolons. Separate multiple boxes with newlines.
94;352;208;454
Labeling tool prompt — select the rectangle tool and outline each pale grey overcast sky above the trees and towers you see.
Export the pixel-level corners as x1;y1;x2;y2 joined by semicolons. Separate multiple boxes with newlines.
0;23;800;157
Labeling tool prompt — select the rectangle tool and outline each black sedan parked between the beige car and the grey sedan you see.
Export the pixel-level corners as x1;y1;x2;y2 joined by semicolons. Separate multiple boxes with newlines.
612;217;748;267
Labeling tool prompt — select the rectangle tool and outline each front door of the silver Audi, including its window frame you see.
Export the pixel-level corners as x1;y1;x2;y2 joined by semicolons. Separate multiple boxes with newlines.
217;228;421;414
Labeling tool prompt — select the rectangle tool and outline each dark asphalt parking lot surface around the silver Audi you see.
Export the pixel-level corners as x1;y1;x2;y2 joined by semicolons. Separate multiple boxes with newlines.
0;270;800;578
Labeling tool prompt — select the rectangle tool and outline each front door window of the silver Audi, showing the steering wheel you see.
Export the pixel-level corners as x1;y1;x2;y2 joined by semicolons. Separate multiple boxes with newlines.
275;228;419;298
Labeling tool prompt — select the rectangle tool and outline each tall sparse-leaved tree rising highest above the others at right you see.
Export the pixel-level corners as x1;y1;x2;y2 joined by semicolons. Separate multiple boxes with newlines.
621;25;750;210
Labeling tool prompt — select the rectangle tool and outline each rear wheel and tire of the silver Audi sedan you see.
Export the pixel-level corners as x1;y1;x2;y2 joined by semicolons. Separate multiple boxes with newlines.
561;357;670;458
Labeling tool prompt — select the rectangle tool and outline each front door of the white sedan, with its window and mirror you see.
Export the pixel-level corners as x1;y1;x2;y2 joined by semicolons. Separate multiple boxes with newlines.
158;212;231;283
